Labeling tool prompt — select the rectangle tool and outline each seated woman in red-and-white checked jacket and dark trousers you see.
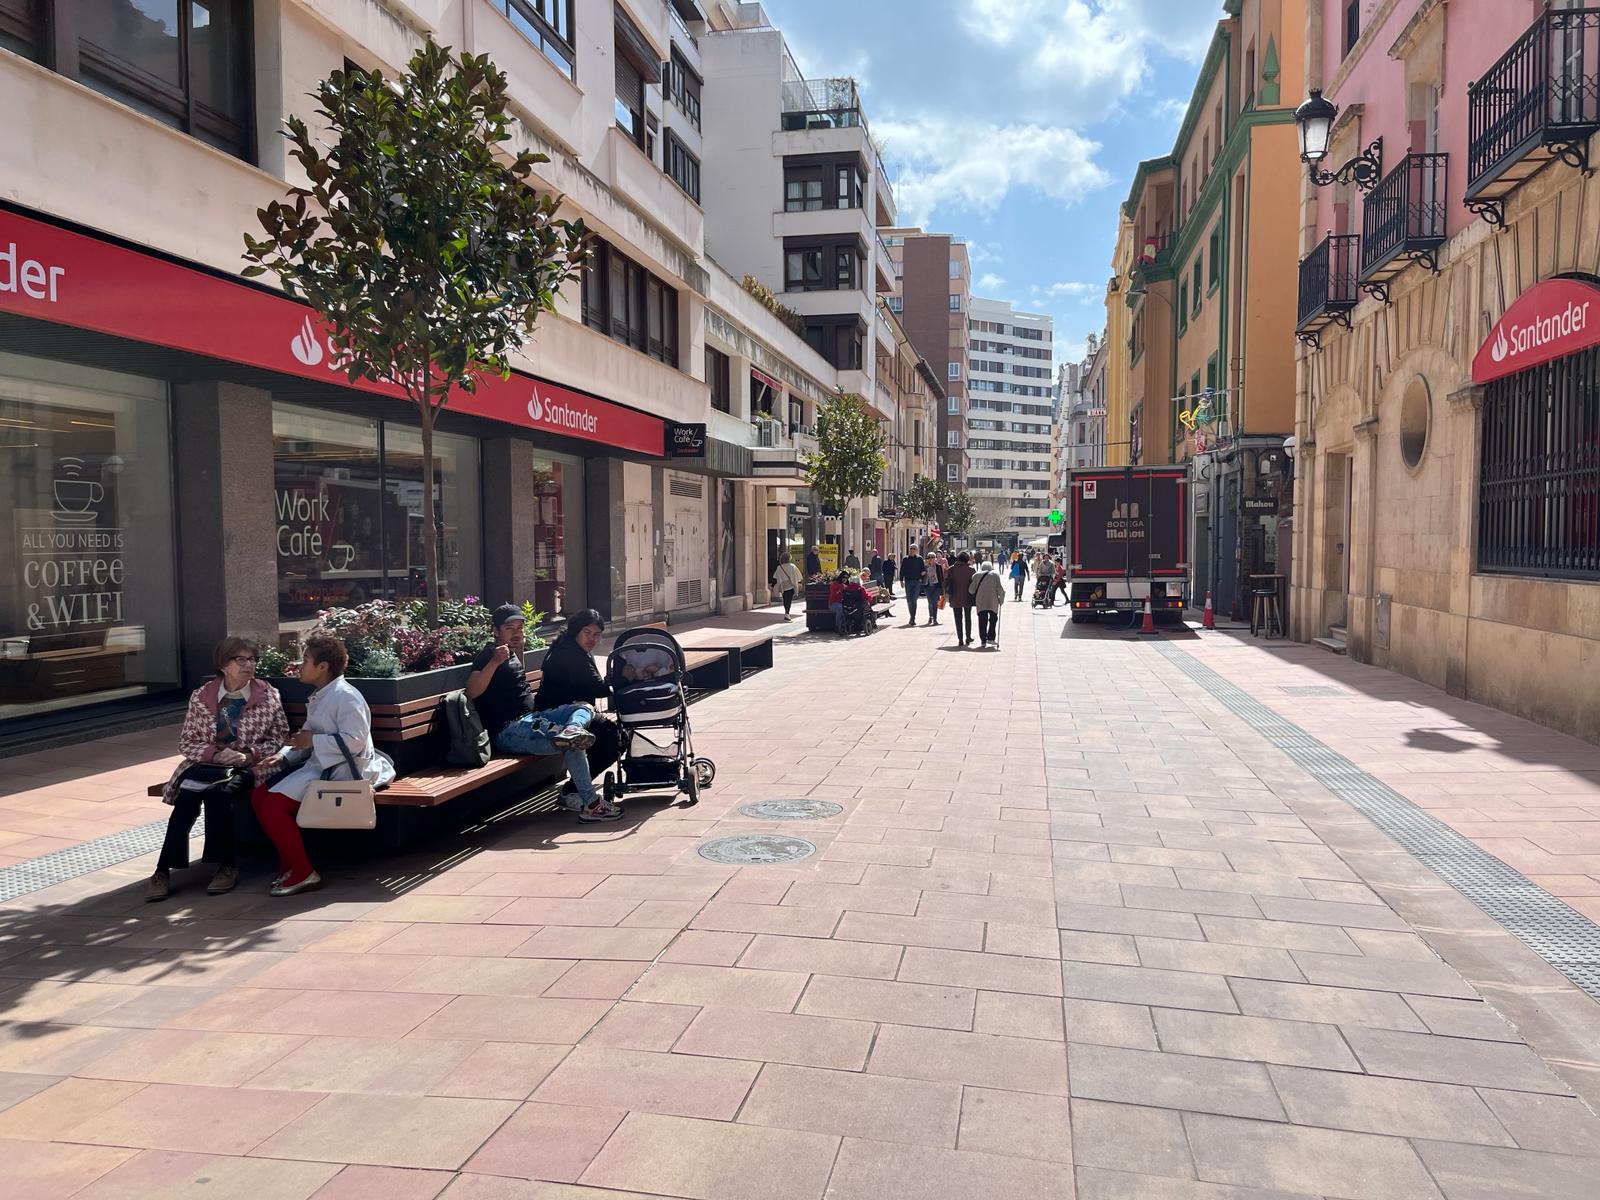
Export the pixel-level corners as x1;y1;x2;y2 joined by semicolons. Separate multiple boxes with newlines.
144;637;290;901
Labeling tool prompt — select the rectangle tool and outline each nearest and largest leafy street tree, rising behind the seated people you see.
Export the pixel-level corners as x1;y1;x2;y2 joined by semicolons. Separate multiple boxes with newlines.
245;40;589;624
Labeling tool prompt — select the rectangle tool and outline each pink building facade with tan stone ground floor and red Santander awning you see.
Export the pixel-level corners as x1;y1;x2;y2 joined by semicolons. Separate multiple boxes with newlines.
1291;0;1600;741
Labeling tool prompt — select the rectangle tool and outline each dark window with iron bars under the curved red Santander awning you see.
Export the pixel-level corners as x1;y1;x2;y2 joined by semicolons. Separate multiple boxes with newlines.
1478;347;1600;579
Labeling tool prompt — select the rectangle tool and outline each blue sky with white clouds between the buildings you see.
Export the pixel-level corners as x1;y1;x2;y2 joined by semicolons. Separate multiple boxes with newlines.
763;0;1222;360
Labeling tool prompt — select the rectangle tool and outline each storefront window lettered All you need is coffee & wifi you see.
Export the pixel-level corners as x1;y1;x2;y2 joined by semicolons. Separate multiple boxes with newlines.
0;354;178;720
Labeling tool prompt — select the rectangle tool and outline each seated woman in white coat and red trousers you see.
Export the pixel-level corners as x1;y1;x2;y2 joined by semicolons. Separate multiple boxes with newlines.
250;634;395;896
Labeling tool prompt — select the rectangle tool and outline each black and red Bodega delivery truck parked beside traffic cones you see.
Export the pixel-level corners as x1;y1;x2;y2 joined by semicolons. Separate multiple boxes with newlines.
1066;466;1189;624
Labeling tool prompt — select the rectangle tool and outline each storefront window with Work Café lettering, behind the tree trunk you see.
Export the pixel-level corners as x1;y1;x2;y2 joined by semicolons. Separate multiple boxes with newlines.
272;405;483;632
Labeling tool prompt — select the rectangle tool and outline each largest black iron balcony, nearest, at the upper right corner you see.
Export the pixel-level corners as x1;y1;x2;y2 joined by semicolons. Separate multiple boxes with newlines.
1464;8;1600;226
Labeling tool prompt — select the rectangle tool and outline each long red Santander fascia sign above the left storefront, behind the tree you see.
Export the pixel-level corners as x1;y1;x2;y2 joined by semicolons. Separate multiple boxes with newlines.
0;210;664;458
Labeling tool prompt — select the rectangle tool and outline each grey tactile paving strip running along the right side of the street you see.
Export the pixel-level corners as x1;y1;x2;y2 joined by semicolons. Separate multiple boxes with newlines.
1155;642;1600;1000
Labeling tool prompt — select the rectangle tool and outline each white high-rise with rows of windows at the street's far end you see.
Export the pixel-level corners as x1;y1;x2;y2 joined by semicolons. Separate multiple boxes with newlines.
966;296;1056;539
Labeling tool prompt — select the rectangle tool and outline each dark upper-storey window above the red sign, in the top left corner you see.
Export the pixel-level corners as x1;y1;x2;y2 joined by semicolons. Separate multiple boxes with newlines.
69;0;253;158
